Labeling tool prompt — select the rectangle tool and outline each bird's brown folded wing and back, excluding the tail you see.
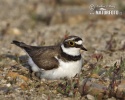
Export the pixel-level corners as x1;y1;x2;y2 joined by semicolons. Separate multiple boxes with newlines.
27;47;59;70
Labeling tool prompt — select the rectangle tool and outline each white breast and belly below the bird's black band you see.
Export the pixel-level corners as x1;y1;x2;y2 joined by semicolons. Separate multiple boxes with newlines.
41;59;82;79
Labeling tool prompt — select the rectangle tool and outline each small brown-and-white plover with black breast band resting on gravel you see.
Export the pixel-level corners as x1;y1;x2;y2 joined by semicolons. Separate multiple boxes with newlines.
12;36;87;80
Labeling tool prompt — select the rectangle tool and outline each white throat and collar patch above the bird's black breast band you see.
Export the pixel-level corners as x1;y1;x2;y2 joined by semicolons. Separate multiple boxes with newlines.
61;44;80;56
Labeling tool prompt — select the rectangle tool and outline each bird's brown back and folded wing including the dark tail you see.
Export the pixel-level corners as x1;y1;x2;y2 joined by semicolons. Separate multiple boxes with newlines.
12;41;60;70
